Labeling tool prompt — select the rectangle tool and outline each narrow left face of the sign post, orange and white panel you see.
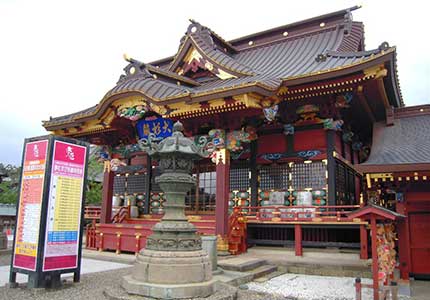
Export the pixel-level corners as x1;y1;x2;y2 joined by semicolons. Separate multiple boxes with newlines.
13;140;48;271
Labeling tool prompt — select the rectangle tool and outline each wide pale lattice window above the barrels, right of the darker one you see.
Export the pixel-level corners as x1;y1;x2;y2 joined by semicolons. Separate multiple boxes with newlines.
291;162;327;191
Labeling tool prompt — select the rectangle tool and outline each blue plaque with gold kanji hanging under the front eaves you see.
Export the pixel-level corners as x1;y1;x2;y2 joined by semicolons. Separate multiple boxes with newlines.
136;118;173;140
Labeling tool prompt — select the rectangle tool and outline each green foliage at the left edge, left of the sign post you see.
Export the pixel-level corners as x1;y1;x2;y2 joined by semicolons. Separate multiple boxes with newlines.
0;163;21;204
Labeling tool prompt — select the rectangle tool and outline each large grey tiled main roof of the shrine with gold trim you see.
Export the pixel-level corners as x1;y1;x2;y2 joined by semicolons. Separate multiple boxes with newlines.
44;7;395;128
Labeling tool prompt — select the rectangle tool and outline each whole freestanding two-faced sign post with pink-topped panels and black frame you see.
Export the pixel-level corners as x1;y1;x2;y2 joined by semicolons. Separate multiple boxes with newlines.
9;136;88;288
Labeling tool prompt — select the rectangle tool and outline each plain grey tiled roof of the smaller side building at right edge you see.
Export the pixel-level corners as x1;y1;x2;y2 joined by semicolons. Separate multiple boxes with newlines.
361;114;430;165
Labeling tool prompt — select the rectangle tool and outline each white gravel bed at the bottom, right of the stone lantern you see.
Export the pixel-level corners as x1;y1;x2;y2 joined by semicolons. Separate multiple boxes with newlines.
248;273;409;300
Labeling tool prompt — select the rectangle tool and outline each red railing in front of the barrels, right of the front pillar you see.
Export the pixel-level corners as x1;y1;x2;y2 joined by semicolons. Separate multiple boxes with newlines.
240;205;360;222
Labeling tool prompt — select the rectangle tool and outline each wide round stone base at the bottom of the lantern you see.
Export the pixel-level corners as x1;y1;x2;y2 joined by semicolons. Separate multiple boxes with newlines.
122;249;215;299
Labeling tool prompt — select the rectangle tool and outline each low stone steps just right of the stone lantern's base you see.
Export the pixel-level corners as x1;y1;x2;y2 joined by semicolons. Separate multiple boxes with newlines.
215;256;285;286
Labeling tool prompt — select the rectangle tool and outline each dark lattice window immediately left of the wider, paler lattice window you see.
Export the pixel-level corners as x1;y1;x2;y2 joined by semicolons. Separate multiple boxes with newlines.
259;164;288;191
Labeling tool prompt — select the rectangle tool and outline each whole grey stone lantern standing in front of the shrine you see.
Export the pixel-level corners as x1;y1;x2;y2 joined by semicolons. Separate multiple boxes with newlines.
122;122;214;299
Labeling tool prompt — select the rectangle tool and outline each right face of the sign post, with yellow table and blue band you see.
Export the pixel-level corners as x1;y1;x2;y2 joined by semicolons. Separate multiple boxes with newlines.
43;141;87;271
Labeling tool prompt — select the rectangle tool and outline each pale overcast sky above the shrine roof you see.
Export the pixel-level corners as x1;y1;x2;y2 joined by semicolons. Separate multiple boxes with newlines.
0;0;430;165
